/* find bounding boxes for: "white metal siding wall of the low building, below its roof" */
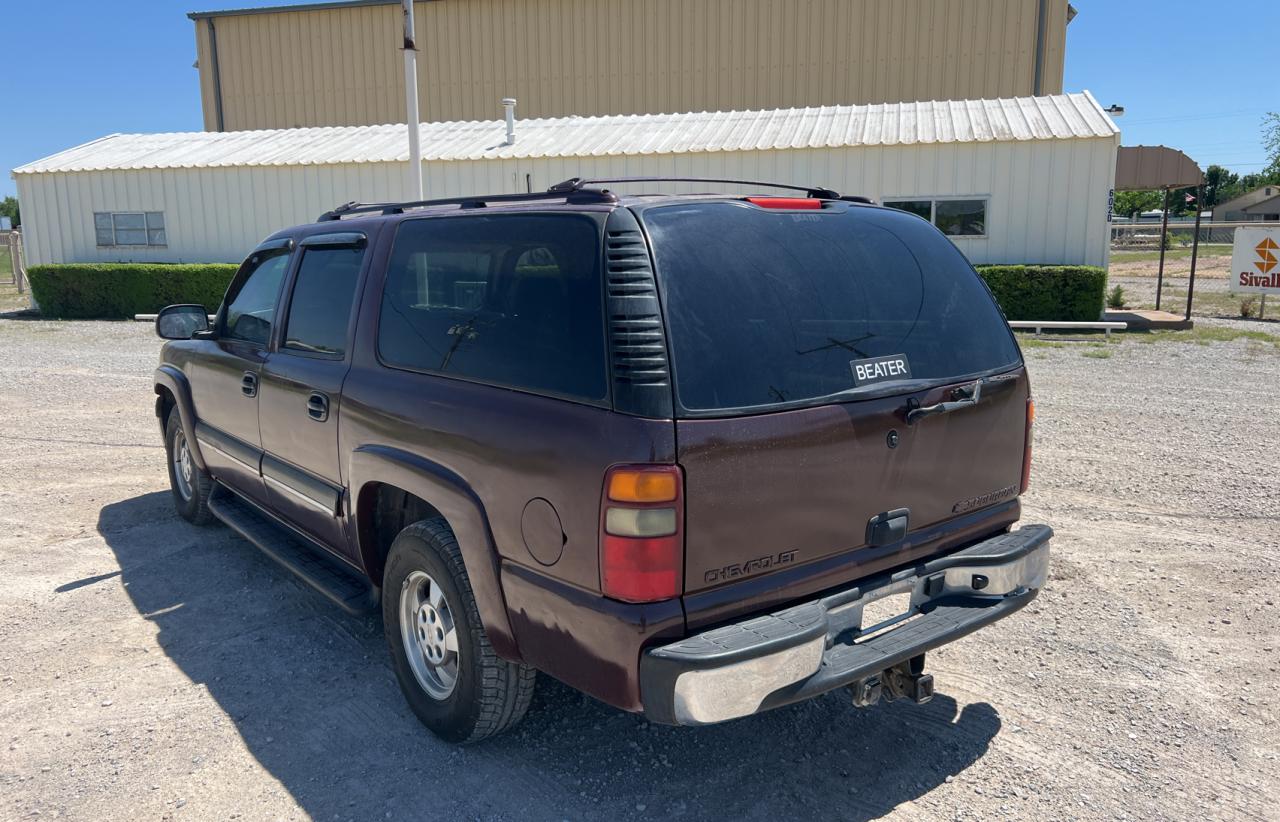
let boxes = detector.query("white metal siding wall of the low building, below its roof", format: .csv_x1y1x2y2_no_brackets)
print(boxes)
15,134,1119,265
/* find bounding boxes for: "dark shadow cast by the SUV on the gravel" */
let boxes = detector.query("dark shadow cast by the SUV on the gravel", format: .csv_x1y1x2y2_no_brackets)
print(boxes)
97,493,1001,819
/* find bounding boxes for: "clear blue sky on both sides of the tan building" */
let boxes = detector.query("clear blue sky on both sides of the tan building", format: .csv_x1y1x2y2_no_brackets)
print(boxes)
0,0,1280,197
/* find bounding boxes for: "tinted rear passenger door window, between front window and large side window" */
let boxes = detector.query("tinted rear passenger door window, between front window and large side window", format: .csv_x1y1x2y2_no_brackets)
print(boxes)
284,248,365,356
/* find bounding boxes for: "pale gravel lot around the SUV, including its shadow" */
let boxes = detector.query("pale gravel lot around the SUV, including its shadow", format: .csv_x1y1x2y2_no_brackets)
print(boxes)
0,320,1280,819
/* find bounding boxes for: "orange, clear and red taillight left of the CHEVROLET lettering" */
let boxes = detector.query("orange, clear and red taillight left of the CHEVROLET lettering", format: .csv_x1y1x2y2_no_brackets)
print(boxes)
600,465,685,602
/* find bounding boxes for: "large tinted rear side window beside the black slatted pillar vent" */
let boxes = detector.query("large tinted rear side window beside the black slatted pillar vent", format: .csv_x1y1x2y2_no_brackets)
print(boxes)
378,214,607,399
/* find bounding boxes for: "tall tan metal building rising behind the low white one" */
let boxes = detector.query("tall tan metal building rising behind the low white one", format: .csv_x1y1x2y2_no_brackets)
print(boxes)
191,0,1075,131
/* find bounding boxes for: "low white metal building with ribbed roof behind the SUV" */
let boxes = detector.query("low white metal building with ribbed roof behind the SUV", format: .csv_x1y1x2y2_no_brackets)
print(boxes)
14,92,1120,265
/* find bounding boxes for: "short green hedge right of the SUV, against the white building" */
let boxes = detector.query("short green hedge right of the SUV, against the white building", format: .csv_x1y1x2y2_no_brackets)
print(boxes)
978,265,1107,323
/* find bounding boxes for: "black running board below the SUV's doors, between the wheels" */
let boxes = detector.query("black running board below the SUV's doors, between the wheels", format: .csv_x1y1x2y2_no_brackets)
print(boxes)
209,487,378,616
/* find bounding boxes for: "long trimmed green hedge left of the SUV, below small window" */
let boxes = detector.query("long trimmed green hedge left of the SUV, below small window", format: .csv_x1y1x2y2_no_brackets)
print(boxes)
28,262,237,320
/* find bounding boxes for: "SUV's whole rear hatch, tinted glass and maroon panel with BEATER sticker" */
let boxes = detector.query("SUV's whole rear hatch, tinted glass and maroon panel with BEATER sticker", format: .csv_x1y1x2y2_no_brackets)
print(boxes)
639,200,1028,594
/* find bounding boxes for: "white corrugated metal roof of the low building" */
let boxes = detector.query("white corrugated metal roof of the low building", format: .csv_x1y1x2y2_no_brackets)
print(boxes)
14,92,1119,174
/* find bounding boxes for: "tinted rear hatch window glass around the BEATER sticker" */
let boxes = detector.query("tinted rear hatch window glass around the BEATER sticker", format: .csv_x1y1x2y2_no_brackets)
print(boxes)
644,202,1020,411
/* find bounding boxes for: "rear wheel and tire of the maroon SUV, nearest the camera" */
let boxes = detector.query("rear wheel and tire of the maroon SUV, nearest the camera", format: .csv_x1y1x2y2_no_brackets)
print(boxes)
383,519,536,745
